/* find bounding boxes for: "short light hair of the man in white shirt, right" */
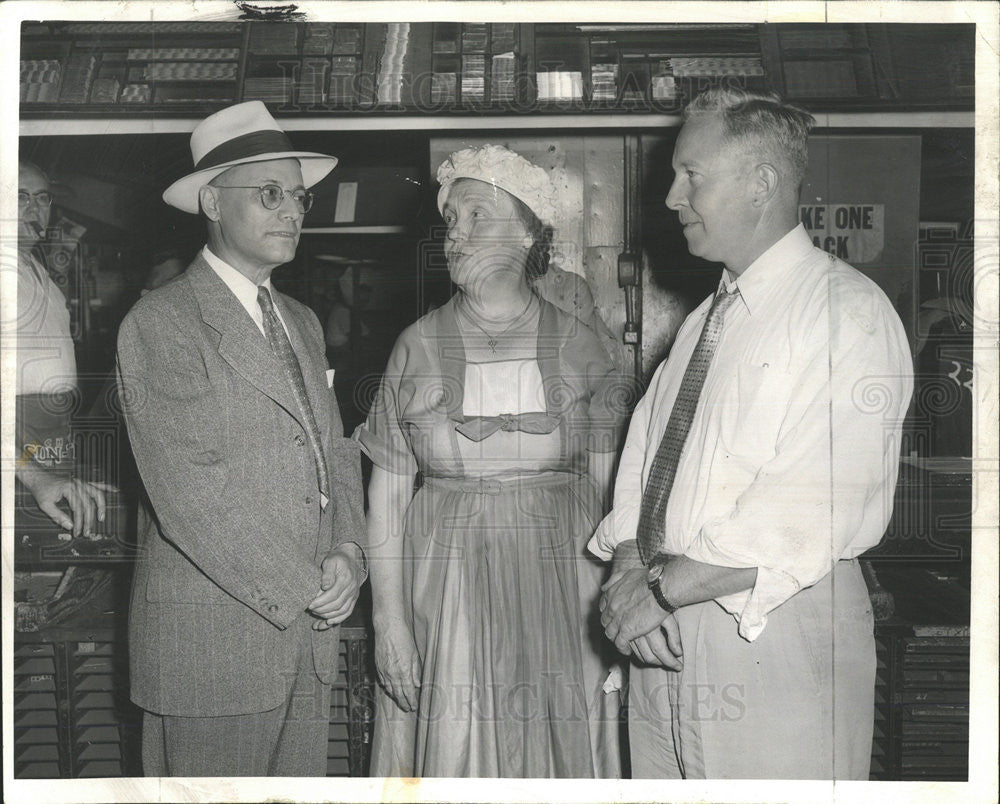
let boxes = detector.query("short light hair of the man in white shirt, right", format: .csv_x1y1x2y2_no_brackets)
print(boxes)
684,87,816,188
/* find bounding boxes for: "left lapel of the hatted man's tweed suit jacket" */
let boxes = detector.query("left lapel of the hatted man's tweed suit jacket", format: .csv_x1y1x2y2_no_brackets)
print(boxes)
188,255,304,426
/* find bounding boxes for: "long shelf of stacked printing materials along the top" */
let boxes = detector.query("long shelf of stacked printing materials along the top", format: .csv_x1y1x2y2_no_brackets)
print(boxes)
21,22,975,115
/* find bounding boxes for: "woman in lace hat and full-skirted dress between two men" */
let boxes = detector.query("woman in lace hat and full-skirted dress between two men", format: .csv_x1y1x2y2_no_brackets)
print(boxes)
355,145,625,777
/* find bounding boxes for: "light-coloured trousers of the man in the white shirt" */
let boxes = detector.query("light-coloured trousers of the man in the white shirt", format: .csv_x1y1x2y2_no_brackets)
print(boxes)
628,560,875,780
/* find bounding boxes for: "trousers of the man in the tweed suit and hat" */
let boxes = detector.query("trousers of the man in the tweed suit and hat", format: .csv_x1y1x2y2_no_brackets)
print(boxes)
142,617,330,777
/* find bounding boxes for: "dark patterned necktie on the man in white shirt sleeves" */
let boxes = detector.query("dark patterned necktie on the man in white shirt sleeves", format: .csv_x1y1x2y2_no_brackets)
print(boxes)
636,288,740,564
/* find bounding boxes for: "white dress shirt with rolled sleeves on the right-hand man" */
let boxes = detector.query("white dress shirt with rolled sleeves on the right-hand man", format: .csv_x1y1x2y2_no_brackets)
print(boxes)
589,225,913,641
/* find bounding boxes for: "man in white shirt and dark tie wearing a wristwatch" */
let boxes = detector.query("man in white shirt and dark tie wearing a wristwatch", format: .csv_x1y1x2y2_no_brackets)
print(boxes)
590,89,913,779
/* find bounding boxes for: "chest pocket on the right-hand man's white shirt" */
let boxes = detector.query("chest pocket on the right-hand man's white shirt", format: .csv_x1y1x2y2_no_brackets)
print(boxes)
722,362,792,464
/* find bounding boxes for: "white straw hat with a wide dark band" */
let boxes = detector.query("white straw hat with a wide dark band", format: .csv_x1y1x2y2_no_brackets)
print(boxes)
163,101,337,214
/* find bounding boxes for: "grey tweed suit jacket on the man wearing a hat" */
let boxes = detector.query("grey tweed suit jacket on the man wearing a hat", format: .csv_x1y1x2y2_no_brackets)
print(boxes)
118,255,365,717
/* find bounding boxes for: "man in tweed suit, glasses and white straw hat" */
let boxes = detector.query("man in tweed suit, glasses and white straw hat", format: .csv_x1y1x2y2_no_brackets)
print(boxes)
118,101,367,776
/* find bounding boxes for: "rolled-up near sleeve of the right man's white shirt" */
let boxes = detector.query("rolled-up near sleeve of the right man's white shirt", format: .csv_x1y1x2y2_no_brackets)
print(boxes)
688,297,913,640
